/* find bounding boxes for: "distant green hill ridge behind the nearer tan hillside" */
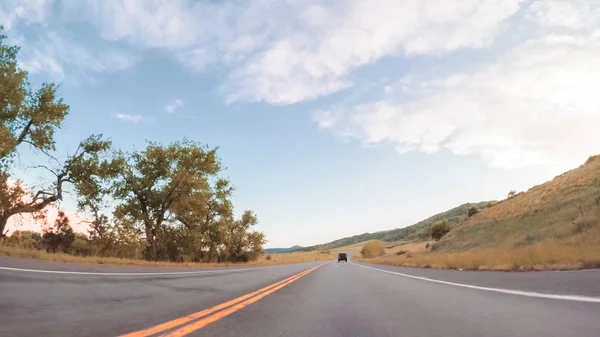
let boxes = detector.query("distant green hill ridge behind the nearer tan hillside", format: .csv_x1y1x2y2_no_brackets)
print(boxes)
304,201,494,251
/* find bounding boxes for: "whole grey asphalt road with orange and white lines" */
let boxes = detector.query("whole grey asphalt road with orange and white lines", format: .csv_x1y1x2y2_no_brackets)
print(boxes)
0,258,600,337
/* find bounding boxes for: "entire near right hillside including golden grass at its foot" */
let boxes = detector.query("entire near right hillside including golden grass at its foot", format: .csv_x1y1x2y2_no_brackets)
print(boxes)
358,156,600,270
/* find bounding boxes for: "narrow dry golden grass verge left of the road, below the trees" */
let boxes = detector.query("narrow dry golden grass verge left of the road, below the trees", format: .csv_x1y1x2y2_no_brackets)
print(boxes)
0,245,335,268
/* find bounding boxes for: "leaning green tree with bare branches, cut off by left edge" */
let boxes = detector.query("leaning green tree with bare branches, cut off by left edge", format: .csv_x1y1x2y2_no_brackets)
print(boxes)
0,26,116,237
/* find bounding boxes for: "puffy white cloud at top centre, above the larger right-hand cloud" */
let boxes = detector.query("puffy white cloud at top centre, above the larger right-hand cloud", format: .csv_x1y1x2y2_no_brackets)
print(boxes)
231,0,521,104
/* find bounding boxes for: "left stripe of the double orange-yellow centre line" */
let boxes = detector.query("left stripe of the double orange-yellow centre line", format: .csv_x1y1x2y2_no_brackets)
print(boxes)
120,265,322,337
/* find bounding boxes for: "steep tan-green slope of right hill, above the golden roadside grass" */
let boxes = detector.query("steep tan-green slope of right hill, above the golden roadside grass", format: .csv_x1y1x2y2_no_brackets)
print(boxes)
438,156,600,251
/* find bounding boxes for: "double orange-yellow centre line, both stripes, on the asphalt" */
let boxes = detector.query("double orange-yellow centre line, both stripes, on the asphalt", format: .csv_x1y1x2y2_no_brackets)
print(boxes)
120,265,322,337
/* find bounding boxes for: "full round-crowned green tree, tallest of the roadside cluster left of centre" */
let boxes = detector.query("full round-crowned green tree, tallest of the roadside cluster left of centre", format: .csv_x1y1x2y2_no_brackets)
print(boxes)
113,140,221,260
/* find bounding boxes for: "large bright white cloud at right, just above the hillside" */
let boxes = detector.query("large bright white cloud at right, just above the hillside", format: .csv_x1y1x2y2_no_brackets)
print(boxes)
314,12,600,168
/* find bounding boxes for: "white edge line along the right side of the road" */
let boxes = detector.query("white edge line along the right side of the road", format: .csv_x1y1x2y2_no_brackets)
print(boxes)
352,263,600,303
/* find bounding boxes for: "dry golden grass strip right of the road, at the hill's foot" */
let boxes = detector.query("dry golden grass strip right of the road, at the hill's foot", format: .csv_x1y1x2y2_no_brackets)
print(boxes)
357,227,600,271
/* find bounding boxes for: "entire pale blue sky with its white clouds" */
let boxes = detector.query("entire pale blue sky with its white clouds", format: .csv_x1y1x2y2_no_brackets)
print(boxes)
0,0,600,247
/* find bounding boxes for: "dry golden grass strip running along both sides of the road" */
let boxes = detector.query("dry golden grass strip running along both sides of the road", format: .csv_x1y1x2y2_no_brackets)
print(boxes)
0,231,600,271
